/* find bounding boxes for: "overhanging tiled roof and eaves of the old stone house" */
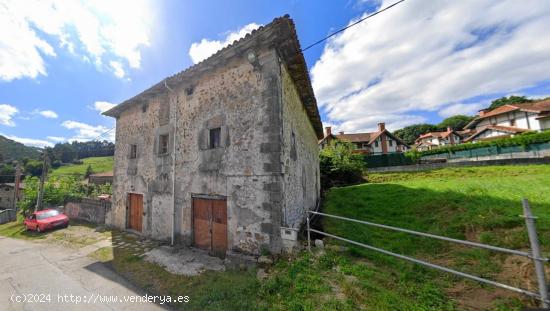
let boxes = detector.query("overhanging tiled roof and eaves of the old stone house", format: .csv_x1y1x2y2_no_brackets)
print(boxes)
103,15,323,139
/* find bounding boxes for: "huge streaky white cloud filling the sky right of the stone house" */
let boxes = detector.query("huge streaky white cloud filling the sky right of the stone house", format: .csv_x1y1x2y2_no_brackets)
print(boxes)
312,0,550,129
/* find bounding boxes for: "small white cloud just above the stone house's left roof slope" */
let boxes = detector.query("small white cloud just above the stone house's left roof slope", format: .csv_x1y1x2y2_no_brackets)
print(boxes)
189,23,261,64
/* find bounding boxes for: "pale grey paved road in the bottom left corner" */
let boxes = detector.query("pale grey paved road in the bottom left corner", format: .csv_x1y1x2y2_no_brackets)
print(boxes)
0,237,166,311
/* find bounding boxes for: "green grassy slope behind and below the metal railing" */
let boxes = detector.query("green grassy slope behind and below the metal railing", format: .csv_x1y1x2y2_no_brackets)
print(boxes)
323,165,550,310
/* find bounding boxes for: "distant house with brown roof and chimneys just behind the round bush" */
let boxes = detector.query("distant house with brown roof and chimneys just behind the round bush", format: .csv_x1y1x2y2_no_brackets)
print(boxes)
319,122,410,155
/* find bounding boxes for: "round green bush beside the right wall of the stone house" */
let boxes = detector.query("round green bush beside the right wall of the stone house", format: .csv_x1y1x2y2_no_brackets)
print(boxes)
319,140,366,189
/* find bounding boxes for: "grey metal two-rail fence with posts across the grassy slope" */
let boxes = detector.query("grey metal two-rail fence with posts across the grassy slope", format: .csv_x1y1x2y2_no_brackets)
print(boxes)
306,199,550,308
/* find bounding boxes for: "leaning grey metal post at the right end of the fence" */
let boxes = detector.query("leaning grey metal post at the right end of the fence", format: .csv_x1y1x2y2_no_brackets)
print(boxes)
522,199,549,308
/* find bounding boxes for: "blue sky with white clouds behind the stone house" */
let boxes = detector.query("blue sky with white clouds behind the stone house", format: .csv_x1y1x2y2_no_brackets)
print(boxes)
0,0,550,146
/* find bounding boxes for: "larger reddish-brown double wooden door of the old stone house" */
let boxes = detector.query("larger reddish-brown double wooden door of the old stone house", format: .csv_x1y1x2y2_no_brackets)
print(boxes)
193,198,227,257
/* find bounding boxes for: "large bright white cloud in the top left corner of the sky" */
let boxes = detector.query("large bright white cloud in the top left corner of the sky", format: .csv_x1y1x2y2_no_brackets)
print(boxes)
0,0,154,81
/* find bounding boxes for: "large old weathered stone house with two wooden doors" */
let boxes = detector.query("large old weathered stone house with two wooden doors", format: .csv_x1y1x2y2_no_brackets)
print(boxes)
104,16,323,257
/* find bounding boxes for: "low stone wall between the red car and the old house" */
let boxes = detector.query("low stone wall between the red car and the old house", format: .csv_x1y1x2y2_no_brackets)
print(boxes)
63,198,111,224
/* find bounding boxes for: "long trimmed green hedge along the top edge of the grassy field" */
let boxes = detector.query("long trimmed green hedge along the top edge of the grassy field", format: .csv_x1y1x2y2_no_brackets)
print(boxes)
405,131,550,160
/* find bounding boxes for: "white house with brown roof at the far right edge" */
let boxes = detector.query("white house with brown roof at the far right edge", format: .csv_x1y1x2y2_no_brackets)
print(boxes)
465,99,550,142
